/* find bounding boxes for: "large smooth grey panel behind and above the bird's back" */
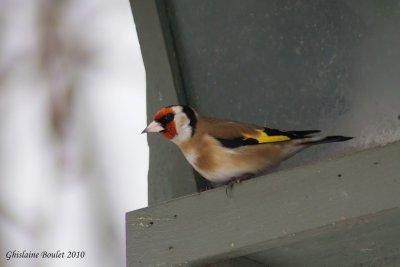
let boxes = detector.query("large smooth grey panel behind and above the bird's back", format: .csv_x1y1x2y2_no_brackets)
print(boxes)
166,0,400,169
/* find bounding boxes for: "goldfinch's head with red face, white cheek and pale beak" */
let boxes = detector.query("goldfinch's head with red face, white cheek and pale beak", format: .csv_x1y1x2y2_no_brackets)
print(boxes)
142,105,198,143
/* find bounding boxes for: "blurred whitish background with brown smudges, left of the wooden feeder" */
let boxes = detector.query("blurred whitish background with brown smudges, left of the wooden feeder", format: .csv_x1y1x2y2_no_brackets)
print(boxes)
0,0,148,267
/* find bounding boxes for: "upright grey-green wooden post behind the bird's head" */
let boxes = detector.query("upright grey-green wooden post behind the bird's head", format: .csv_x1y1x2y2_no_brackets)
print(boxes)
130,0,196,203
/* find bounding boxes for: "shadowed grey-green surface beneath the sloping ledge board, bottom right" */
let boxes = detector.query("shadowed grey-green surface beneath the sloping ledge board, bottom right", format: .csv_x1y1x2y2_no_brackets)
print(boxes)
248,208,400,267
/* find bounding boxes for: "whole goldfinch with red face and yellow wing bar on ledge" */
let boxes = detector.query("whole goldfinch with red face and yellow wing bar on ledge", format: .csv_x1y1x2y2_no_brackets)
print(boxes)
142,105,352,185
